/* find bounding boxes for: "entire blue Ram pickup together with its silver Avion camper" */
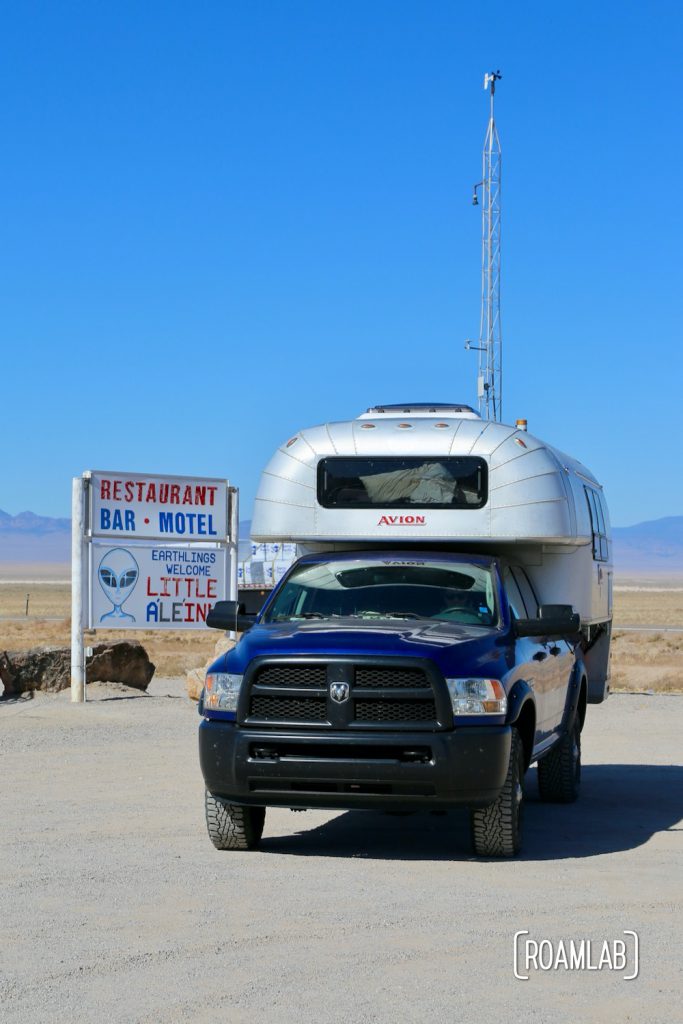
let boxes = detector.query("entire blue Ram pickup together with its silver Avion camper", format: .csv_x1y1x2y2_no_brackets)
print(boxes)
200,403,612,856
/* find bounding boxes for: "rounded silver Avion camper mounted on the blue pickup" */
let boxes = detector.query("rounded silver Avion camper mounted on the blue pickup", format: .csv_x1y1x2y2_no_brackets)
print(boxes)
252,403,612,702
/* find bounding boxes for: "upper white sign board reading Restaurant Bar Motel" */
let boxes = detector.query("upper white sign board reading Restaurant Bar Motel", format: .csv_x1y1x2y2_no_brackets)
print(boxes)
89,470,228,544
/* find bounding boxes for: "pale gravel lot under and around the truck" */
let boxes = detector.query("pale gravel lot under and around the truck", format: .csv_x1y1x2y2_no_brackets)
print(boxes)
0,680,683,1024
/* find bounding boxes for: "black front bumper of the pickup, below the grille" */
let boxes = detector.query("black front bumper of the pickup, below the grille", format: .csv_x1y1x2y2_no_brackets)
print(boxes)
200,719,510,809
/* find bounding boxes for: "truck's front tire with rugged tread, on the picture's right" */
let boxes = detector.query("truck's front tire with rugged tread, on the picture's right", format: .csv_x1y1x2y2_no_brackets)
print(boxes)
470,729,524,857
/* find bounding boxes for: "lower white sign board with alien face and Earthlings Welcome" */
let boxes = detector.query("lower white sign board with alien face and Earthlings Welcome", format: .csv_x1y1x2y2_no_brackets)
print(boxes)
87,541,227,630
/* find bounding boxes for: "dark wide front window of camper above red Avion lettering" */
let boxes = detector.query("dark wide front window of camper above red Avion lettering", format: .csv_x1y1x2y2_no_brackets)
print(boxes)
317,456,487,509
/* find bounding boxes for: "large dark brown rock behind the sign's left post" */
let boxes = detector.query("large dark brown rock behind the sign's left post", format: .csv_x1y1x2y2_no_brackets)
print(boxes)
0,640,155,696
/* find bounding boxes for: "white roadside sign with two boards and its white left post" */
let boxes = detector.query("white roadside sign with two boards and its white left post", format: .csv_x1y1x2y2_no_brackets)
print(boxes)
72,470,233,701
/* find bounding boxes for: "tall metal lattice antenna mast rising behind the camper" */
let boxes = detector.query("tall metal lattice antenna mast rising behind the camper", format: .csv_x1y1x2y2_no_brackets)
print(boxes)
466,71,503,421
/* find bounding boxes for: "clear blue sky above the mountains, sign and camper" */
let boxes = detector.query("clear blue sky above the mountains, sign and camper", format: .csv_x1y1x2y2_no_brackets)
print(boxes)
0,0,683,525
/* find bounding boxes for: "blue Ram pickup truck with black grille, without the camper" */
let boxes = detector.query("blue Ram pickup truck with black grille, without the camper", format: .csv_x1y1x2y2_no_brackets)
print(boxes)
199,549,587,857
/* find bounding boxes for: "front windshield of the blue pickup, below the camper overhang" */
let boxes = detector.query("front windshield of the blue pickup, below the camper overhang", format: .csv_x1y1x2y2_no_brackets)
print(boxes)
263,558,498,627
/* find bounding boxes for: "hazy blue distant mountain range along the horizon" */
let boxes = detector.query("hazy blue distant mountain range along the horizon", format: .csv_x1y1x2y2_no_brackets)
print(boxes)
0,510,683,572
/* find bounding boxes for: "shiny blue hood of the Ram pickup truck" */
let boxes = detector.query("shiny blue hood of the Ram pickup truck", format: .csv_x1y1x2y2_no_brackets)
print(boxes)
219,618,507,678
